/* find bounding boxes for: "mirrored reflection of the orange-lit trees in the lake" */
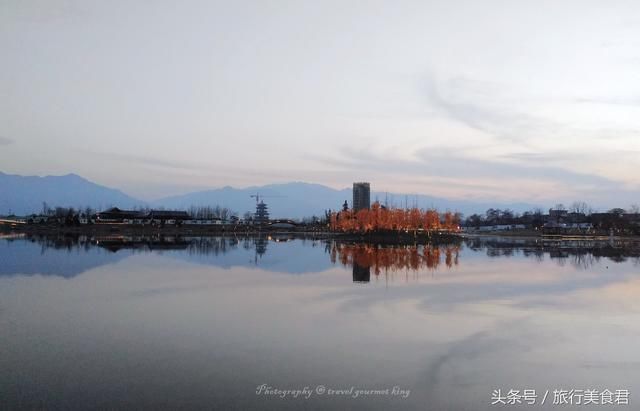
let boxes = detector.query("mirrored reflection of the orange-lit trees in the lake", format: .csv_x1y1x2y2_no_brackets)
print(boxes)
331,243,460,275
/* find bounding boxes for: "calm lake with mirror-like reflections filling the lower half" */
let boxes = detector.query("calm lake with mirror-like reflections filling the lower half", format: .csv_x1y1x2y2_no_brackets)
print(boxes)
0,236,640,411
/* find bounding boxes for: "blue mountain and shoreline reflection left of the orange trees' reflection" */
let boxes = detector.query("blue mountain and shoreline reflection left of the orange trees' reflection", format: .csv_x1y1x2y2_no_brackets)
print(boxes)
0,234,338,277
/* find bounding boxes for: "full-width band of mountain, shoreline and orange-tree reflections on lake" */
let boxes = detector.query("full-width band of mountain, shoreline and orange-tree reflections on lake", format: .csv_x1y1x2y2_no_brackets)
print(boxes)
0,235,640,283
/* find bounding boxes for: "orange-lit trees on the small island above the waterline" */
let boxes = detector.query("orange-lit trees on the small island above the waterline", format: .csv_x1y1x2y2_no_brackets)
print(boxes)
330,202,460,232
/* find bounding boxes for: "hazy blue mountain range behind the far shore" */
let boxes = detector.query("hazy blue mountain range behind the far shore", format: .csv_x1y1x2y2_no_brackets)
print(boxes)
0,172,538,218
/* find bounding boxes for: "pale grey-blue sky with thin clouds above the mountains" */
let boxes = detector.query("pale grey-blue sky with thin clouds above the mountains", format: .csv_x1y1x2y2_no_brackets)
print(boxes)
0,0,640,207
